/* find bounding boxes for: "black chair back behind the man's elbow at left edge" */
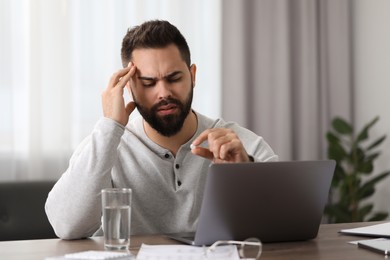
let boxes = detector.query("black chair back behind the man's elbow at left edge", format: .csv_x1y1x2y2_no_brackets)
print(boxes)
0,181,57,241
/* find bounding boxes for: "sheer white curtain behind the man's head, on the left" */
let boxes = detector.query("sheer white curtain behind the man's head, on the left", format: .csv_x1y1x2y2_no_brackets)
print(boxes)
0,0,221,181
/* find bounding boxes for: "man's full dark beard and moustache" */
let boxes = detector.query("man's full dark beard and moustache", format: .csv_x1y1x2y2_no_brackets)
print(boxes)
133,85,193,137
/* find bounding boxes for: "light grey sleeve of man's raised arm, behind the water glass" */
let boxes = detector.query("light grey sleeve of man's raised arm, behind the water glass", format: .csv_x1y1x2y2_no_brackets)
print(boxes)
45,118,125,239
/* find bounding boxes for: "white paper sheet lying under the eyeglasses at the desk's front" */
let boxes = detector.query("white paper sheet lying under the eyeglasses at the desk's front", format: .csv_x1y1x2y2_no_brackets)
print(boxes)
137,244,240,260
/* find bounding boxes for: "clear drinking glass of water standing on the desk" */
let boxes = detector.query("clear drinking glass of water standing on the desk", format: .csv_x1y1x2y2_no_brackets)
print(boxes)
102,188,131,250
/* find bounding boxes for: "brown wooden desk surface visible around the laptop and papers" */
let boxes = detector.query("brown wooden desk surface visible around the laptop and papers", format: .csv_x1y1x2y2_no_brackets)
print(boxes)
0,223,384,260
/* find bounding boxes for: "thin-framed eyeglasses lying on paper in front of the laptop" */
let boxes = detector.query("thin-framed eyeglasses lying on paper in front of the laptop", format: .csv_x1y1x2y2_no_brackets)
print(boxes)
205,238,263,259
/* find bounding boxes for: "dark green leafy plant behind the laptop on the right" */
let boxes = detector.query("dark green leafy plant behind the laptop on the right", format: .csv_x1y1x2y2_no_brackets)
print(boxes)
325,117,390,223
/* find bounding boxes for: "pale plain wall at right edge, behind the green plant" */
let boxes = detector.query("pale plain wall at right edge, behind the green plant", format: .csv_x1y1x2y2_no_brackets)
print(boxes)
353,0,390,219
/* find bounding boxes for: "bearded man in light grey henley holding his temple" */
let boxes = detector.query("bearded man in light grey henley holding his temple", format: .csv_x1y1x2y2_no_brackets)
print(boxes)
45,21,277,239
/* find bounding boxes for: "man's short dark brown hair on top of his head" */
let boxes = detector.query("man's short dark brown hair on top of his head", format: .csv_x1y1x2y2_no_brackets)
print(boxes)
121,20,191,67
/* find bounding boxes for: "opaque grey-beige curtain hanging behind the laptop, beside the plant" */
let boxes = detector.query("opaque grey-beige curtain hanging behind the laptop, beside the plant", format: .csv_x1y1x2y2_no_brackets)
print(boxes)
222,0,353,160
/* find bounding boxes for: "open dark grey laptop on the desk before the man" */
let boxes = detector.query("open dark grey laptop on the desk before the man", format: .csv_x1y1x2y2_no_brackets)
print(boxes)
167,160,336,246
